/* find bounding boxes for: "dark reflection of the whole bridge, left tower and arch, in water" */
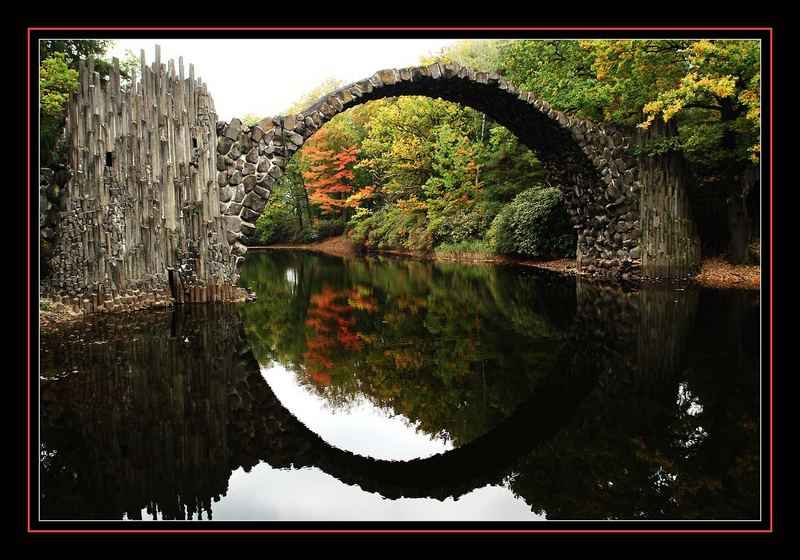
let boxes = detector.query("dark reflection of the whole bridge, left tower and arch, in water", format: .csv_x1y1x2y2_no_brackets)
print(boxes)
42,287,692,519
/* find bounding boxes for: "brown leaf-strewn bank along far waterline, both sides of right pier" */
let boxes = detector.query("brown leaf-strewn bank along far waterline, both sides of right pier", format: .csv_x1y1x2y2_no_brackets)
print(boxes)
250,235,761,290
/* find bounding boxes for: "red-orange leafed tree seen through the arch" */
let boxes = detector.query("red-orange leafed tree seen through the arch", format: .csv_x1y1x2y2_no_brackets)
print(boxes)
303,128,359,214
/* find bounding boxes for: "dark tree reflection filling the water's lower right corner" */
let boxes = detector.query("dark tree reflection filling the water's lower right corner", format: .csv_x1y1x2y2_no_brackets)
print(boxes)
504,289,759,519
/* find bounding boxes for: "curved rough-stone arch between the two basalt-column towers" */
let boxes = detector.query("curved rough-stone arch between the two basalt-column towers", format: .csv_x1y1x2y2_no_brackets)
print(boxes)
217,63,642,279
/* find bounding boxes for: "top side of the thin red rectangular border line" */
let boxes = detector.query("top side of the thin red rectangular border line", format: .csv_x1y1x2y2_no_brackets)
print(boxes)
28,27,772,30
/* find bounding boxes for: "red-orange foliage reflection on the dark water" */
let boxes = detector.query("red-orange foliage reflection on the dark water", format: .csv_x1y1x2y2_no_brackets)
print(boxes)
303,286,374,387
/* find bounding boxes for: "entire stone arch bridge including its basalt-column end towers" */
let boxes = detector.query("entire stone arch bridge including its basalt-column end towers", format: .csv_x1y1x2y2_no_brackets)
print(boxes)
39,52,700,313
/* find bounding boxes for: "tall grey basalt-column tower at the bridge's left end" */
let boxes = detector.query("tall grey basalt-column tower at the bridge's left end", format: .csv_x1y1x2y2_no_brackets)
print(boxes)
42,48,238,312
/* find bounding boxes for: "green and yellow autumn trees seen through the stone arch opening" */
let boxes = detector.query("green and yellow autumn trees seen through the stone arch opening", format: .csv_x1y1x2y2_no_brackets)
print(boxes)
248,95,576,258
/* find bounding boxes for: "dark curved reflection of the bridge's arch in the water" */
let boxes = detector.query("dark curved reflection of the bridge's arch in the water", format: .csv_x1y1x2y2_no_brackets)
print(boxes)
229,344,594,499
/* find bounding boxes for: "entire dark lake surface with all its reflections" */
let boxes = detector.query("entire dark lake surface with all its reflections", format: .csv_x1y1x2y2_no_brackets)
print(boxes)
40,251,760,520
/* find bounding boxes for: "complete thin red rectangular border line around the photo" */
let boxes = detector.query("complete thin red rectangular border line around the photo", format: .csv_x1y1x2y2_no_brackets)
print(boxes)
27,27,774,533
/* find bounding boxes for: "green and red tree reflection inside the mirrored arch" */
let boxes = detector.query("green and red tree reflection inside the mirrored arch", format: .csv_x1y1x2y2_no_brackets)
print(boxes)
243,254,574,443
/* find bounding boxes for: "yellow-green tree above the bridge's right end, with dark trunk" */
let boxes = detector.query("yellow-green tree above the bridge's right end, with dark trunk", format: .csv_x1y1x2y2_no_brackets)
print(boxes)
499,40,761,262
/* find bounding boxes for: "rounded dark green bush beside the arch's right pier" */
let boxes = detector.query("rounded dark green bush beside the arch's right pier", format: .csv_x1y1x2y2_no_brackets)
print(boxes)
488,186,575,258
